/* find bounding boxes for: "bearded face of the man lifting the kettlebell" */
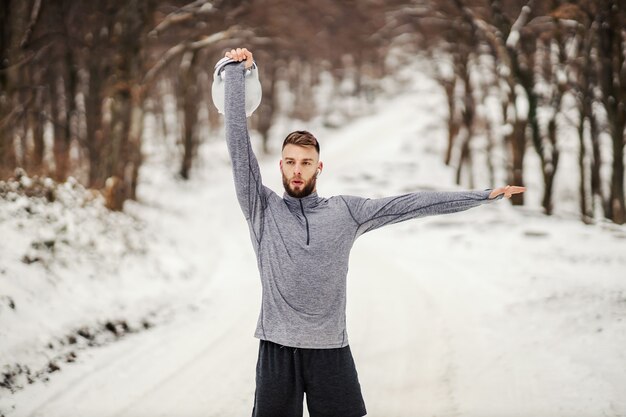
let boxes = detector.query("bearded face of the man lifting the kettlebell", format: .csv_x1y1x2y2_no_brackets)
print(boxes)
280,143,322,198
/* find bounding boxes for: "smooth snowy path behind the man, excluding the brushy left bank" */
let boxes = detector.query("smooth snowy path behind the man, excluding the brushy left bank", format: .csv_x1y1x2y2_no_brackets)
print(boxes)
2,75,626,417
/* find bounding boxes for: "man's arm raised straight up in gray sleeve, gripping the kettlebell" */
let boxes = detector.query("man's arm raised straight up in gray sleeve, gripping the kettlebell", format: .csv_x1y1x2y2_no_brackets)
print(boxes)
219,51,268,242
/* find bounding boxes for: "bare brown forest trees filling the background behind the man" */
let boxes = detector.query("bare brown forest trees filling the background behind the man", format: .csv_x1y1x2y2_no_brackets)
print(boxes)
0,0,626,224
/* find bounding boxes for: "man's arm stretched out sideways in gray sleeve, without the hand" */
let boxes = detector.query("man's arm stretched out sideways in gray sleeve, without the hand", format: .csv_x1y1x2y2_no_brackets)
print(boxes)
341,190,503,235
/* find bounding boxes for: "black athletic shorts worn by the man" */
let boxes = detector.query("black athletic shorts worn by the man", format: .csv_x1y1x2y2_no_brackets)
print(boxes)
252,340,367,417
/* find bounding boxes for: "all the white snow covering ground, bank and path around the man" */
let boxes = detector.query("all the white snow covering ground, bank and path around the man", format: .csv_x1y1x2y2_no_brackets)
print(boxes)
0,65,626,417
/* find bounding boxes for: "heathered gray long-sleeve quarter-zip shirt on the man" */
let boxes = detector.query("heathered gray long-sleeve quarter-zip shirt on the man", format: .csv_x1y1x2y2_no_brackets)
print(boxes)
225,63,501,348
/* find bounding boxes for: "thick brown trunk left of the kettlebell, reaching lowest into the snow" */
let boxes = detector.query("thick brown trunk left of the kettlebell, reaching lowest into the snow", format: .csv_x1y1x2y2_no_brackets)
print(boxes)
87,0,155,210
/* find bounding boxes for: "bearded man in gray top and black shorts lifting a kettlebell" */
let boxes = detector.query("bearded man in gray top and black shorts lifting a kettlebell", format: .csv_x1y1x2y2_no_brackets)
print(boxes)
216,48,525,417
